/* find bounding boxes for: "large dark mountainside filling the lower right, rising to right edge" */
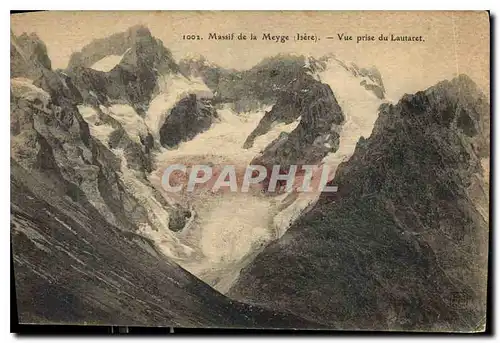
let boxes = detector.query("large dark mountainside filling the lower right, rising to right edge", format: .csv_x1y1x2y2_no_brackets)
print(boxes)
228,75,489,331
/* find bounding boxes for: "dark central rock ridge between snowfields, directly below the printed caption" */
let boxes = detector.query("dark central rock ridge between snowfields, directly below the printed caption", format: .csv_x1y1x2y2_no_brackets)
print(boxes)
180,55,348,168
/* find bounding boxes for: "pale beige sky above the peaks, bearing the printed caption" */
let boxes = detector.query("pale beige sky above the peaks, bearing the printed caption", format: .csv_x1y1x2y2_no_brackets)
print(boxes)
11,11,490,99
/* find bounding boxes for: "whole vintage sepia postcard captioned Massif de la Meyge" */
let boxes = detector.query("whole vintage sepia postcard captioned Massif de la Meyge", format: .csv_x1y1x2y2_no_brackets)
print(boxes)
10,11,490,332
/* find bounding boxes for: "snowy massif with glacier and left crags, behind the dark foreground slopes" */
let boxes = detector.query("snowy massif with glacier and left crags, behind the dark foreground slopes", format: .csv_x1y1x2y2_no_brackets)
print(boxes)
11,26,394,298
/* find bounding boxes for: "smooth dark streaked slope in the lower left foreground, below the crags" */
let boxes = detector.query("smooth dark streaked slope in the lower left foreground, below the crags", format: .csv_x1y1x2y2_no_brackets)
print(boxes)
11,162,320,328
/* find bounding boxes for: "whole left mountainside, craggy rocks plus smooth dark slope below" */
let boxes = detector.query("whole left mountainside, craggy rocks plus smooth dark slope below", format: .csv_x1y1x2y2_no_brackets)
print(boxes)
11,29,319,328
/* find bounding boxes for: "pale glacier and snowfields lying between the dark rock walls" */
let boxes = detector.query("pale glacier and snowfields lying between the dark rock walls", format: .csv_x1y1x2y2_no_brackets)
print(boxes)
79,59,390,292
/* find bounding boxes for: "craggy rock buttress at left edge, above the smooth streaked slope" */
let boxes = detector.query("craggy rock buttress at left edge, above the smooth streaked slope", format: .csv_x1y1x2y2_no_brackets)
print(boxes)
11,66,152,235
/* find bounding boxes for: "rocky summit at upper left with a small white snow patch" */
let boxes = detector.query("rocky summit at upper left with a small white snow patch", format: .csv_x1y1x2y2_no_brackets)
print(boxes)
67,26,178,114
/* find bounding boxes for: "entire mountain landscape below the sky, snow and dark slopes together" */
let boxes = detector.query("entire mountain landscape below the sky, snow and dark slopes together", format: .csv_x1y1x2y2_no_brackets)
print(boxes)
11,26,490,331
